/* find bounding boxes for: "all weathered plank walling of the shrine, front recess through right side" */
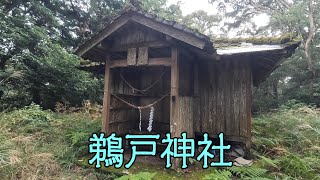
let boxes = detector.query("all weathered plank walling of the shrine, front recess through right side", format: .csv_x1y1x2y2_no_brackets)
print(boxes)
104,23,252,146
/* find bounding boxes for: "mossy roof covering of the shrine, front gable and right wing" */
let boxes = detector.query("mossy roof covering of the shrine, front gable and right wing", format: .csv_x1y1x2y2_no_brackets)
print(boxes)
75,6,300,55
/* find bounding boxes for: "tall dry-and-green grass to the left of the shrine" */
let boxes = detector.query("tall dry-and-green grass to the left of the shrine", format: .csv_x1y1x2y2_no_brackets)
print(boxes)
0,105,100,179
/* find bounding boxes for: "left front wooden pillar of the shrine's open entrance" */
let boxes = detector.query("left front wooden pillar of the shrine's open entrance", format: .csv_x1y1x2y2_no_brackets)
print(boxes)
101,54,111,135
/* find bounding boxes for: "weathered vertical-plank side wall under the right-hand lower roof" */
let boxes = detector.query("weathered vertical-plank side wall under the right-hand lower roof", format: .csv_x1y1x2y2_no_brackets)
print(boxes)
194,59,252,145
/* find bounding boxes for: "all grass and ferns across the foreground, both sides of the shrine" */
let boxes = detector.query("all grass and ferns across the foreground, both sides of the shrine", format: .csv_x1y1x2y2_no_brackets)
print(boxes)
0,103,320,180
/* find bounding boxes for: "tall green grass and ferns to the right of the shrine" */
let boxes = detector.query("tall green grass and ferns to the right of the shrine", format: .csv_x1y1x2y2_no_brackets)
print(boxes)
253,102,320,179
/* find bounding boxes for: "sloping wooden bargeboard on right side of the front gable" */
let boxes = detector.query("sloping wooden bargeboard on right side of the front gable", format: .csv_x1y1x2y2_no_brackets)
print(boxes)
131,15,206,49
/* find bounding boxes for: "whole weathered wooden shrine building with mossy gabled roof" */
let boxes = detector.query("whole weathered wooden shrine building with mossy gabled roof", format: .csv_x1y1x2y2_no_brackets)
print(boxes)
76,9,299,147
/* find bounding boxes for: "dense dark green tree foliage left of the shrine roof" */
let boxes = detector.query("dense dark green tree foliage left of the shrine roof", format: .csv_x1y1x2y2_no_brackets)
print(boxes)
0,0,188,111
